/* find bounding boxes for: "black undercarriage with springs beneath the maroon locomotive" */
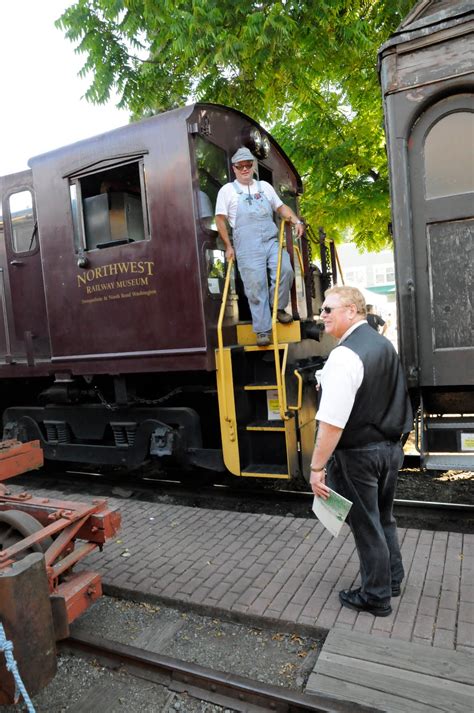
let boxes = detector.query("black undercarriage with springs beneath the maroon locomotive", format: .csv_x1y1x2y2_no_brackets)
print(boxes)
3,377,225,471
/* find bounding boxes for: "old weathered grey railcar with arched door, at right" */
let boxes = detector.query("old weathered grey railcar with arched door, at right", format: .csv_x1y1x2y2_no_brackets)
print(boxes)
379,0,474,470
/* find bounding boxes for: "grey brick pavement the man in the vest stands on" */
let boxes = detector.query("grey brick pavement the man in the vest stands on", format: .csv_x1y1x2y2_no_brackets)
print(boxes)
60,493,474,653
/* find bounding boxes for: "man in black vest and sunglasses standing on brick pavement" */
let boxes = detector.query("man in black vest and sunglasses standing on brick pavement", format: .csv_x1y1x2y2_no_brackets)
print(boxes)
310,287,413,616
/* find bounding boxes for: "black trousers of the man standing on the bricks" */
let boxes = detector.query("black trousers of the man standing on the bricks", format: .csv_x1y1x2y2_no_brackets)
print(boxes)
327,441,404,604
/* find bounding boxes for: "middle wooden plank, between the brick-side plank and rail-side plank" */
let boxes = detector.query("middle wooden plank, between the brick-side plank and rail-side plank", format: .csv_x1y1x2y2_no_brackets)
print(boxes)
316,648,474,713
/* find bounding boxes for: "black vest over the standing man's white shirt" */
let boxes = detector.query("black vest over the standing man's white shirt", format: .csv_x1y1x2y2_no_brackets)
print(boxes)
336,324,413,448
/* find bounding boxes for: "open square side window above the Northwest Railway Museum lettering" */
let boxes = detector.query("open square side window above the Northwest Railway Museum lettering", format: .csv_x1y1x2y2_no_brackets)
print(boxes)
70,160,150,252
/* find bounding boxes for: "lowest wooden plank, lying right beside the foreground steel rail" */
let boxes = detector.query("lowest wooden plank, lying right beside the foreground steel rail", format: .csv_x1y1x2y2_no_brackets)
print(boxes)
305,673,435,713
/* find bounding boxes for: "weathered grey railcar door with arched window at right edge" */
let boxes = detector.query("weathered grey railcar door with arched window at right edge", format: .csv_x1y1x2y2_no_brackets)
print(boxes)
409,94,474,386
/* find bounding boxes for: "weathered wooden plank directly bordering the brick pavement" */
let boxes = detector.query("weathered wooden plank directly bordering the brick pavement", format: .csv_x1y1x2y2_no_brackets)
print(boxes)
323,629,474,684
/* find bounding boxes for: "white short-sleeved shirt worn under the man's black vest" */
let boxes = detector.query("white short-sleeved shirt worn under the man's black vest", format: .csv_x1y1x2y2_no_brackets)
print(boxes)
316,319,367,428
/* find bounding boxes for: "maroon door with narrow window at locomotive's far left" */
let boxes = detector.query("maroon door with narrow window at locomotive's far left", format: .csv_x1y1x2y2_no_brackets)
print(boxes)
0,171,50,365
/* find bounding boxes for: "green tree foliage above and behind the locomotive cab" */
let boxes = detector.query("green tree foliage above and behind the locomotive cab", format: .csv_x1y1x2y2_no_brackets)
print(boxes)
57,0,415,249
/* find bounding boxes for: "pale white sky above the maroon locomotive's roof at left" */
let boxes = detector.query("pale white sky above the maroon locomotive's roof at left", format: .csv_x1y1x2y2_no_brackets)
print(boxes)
0,0,128,176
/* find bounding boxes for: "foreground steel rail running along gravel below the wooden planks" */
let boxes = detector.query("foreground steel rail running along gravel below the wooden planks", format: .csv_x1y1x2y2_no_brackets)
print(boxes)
58,633,380,713
